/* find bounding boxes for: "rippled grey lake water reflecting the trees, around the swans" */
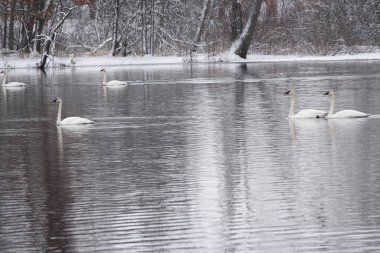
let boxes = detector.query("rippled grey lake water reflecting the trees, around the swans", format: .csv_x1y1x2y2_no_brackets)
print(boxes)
0,61,380,253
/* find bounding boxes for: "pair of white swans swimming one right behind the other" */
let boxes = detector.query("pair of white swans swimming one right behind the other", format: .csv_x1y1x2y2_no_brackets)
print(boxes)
284,89,370,119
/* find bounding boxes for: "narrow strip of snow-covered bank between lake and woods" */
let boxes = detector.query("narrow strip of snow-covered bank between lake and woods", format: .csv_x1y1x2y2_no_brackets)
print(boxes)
0,53,380,69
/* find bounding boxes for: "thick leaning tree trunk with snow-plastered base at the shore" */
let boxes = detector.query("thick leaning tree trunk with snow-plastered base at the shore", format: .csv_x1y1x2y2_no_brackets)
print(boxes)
230,0,263,59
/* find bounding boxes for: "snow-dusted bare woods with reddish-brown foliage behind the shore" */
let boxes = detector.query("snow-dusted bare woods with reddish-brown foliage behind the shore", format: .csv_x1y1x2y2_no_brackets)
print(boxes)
0,0,380,57
